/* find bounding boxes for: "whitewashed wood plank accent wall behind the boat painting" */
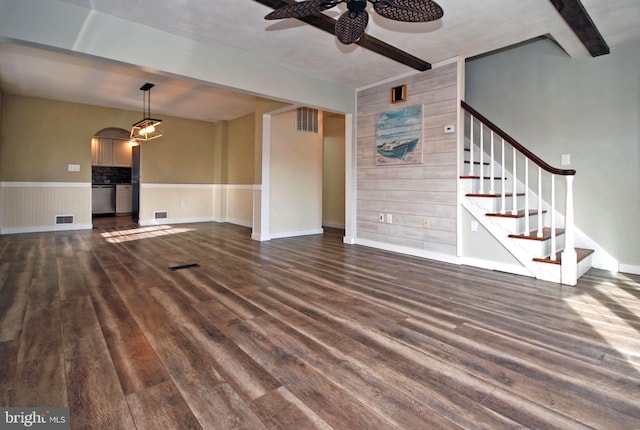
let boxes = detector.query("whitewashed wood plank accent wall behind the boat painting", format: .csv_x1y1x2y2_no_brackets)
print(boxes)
356,63,459,256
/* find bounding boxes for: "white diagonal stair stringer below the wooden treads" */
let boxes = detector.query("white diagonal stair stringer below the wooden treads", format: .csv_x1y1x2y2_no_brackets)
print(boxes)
461,196,561,282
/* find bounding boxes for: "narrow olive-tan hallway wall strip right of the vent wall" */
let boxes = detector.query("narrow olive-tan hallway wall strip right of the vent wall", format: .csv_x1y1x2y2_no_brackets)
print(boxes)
322,112,345,228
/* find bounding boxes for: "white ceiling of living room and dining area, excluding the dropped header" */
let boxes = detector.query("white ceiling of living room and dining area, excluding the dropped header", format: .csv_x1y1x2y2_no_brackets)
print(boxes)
0,0,640,121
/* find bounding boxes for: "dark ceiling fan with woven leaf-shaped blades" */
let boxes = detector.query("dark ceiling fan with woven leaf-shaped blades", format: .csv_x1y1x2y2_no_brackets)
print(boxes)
264,0,444,45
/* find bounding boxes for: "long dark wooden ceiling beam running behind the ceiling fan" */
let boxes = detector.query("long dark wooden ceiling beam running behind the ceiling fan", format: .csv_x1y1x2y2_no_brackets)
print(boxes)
250,0,431,72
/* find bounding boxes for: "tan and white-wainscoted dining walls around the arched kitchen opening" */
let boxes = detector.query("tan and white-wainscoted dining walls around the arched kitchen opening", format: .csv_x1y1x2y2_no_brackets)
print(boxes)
0,95,254,233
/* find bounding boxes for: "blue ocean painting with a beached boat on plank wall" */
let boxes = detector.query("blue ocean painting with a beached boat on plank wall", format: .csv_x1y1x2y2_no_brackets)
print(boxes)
376,105,422,166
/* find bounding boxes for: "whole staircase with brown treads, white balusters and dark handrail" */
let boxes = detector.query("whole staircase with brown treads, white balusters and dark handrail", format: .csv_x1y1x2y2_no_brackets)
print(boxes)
460,101,593,285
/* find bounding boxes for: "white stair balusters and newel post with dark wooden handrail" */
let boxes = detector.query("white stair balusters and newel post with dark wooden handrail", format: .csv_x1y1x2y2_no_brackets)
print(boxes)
461,101,577,285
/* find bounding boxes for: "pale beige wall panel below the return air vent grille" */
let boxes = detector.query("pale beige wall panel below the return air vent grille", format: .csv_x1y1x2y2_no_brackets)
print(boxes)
270,107,322,237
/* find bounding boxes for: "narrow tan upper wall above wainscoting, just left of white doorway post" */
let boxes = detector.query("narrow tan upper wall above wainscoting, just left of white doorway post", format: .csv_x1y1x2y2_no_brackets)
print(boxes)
226,113,256,184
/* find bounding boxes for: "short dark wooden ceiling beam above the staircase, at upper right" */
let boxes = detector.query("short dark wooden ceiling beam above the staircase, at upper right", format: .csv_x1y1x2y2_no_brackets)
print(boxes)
549,0,609,57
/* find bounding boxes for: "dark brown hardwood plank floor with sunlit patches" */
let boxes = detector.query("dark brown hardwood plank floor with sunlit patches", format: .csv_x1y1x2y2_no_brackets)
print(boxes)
0,223,640,430
